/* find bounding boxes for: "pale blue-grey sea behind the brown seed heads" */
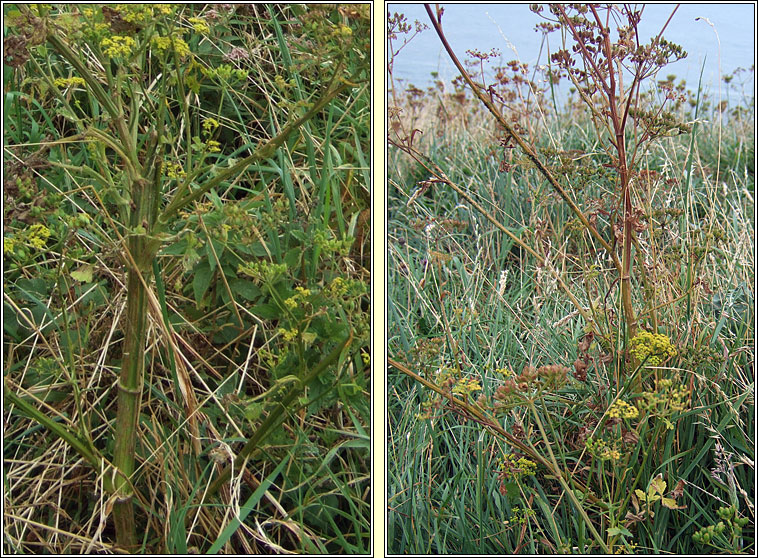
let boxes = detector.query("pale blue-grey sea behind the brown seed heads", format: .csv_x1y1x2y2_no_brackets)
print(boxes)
387,2,756,98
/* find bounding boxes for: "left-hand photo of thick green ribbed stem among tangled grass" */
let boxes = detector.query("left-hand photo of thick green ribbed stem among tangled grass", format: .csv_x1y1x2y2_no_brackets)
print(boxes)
3,4,370,554
